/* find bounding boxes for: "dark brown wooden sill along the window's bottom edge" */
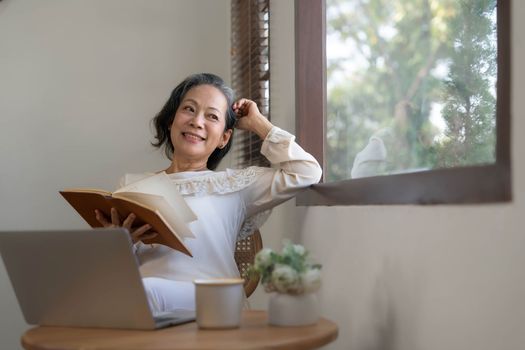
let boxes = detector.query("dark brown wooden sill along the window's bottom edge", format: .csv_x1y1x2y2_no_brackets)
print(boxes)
296,164,512,206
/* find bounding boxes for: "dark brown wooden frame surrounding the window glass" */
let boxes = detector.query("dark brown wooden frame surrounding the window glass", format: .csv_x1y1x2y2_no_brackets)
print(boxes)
295,0,512,205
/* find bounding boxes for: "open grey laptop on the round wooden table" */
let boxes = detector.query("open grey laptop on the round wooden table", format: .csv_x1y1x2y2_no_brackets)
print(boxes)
0,228,195,329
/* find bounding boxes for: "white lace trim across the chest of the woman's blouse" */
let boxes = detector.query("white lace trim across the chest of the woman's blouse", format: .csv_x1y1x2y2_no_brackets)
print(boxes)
169,166,264,197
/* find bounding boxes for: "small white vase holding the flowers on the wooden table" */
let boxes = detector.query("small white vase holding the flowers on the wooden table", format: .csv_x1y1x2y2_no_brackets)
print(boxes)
268,293,319,326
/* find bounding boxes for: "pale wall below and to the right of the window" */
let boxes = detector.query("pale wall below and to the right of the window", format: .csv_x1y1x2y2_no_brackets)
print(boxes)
264,0,525,350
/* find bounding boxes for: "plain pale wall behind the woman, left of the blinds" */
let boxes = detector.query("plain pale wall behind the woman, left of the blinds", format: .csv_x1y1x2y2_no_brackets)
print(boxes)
0,0,230,349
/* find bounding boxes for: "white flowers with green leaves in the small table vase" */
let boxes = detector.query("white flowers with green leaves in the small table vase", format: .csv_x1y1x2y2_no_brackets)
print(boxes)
247,241,321,295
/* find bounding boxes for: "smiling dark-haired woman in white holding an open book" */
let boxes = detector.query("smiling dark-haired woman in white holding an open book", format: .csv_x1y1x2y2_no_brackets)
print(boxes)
97,74,321,311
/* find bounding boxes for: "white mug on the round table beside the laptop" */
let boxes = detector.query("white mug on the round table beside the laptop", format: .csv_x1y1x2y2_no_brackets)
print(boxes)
193,278,244,328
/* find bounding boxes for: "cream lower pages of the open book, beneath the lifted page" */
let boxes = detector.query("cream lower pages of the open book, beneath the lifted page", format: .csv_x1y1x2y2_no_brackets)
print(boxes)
113,192,195,238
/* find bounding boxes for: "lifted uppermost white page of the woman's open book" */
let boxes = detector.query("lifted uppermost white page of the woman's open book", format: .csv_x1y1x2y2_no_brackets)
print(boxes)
113,172,197,222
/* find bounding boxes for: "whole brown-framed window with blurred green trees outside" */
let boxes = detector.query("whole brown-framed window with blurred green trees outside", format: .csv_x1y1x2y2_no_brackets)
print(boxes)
296,0,511,205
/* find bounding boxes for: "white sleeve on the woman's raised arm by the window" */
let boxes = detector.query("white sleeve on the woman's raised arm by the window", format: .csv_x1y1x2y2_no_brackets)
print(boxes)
241,126,322,217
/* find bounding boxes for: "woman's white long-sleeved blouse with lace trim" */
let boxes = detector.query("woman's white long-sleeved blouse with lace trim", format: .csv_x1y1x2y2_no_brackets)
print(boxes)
121,126,321,281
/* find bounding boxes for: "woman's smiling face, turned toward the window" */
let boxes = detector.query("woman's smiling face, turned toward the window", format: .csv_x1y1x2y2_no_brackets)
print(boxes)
170,85,232,165
